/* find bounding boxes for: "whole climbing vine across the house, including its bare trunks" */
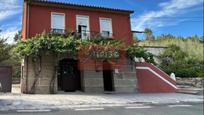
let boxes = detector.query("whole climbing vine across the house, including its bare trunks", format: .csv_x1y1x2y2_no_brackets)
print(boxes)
15,33,153,93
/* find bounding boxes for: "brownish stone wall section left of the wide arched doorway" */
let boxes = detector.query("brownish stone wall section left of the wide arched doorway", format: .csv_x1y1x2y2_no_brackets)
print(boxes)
21,55,57,94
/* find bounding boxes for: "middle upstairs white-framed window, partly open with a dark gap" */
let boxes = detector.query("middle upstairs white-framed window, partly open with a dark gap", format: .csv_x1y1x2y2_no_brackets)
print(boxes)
76,15,90,40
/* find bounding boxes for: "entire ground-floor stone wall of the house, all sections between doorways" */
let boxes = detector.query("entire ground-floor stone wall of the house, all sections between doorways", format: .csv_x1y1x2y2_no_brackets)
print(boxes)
21,55,137,94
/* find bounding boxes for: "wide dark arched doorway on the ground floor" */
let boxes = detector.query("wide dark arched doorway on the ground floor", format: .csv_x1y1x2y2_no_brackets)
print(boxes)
58,59,81,91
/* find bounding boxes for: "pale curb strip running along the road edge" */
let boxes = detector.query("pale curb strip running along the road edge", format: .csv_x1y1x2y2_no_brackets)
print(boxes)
0,101,203,113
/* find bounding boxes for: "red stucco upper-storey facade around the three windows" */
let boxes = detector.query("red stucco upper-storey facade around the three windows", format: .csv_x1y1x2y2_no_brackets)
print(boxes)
22,2,133,44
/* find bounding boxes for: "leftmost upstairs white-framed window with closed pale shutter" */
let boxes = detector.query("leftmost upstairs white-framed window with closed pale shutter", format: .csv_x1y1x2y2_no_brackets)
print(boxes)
51,12,65,33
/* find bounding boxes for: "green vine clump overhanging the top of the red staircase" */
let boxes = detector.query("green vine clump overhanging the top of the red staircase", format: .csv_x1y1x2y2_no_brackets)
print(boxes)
126,45,155,64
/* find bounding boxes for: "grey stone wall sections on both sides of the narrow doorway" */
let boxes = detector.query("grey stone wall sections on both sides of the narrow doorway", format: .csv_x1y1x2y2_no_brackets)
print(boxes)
81,61,137,93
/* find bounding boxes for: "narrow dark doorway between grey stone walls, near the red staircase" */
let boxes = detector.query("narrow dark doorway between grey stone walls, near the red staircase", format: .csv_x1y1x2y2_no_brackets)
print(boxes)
103,61,114,91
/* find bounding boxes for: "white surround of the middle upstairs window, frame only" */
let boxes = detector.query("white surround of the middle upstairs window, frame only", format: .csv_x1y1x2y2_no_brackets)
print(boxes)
76,15,90,39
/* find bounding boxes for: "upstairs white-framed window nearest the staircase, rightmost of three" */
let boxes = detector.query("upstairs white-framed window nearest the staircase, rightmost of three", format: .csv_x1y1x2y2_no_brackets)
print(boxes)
99,18,113,38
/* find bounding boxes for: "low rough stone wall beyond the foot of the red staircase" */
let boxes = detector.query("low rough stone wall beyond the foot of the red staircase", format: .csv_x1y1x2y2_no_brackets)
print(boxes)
176,77,204,88
